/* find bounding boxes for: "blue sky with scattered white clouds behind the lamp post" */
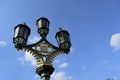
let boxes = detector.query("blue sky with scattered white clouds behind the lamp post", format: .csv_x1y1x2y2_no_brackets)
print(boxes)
0,0,120,80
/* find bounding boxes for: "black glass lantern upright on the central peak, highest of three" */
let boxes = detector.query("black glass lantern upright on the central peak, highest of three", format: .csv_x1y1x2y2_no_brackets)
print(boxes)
36,17,50,37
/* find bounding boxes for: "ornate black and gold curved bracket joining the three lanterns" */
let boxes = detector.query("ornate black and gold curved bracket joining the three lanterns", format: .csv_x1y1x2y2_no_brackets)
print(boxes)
16,38,64,67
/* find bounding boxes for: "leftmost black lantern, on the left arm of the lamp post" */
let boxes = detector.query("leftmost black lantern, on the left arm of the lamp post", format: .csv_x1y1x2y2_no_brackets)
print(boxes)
13,24,31,45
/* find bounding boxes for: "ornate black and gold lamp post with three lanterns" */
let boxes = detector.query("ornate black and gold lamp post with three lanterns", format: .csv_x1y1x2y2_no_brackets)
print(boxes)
13,17,71,80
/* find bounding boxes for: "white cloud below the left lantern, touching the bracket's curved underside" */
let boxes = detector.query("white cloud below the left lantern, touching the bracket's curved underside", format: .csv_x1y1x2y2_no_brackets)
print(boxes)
19,52,37,66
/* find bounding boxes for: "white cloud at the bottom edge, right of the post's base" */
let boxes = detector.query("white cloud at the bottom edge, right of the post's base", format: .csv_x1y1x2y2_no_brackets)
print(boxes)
51,71,72,80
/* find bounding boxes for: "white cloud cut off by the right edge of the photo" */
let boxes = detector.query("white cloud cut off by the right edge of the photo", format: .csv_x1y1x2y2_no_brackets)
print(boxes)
110,33,120,50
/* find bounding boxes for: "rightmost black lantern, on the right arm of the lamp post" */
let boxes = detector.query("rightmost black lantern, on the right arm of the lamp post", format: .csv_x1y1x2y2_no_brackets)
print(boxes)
55,28,71,53
